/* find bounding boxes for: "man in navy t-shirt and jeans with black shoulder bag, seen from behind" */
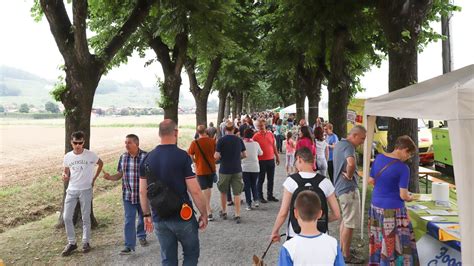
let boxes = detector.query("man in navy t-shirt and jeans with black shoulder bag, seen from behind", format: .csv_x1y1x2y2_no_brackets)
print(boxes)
140,119,208,265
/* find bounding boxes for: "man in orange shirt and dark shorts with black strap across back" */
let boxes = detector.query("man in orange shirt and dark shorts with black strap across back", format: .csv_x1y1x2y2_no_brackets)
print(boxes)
188,125,217,221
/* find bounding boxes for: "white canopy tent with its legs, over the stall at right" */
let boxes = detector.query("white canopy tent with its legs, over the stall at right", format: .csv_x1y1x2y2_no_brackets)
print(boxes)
361,65,474,265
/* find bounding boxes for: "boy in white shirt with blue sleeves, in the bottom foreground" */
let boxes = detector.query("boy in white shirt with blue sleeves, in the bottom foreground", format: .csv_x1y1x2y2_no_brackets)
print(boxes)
278,190,345,266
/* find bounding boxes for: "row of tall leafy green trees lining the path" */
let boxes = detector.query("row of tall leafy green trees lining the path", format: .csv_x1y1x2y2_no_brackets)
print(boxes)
32,0,456,227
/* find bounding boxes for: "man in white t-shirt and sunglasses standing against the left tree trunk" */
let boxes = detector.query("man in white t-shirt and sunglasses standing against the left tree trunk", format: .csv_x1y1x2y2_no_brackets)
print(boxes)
61,131,104,256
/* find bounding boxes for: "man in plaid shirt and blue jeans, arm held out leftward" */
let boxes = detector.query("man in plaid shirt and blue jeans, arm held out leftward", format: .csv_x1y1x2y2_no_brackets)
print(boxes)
104,134,148,255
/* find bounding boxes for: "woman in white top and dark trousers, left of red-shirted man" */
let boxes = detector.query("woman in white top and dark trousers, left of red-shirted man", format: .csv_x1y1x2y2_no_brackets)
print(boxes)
242,128,263,211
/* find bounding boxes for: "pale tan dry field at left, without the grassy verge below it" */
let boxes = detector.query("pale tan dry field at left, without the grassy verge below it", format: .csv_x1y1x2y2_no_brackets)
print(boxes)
0,115,216,187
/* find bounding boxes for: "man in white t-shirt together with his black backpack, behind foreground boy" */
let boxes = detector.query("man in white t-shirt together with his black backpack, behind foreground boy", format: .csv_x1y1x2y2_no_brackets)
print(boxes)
271,147,341,242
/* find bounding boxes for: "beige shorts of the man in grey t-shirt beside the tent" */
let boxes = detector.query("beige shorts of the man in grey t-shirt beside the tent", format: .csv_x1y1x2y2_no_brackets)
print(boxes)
338,189,360,229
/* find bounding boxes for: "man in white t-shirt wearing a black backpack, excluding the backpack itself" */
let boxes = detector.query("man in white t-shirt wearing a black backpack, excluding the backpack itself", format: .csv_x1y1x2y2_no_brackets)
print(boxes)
271,147,341,242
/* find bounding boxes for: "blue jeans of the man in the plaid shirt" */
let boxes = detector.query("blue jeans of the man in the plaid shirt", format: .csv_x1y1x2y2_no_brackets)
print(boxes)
123,200,146,250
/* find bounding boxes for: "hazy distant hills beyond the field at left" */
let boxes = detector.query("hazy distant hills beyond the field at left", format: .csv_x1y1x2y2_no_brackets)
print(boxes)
0,66,159,108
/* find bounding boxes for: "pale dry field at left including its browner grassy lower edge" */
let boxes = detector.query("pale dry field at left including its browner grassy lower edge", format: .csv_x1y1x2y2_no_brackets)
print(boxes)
0,115,215,233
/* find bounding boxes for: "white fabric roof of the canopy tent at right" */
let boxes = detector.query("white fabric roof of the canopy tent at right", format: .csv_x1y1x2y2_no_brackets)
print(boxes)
365,65,474,120
